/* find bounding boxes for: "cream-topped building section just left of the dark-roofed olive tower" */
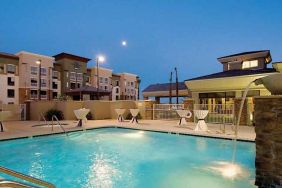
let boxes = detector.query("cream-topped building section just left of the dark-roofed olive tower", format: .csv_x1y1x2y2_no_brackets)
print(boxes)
16,51,55,103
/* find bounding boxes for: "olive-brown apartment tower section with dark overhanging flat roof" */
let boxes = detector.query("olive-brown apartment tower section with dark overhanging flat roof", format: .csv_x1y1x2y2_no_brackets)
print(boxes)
53,52,90,99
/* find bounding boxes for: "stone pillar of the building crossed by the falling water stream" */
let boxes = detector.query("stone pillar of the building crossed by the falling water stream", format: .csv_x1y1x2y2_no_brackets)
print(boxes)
234,98,248,125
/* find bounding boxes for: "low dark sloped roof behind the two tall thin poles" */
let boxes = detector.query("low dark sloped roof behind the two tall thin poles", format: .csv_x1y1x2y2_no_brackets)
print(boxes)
142,82,187,92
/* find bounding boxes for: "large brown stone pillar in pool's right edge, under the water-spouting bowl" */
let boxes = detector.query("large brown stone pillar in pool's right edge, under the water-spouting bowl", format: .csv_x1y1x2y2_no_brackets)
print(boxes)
254,96,282,188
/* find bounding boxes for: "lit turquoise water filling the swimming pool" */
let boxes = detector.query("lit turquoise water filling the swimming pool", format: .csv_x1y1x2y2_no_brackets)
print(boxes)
0,128,255,188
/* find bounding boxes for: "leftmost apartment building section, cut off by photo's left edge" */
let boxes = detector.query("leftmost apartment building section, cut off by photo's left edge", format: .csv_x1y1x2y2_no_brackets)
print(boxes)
0,53,19,104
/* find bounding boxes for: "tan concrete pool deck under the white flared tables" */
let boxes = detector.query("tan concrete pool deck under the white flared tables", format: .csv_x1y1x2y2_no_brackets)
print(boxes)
0,119,256,141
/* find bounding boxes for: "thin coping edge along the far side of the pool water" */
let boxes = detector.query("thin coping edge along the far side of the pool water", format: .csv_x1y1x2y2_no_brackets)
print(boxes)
0,125,255,143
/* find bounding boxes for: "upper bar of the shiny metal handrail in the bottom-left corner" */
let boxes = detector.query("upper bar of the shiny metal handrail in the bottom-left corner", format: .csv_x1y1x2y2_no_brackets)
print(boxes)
0,166,55,188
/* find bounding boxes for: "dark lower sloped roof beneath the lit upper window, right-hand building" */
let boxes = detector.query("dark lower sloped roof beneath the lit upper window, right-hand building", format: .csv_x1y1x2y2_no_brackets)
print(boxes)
185,68,276,81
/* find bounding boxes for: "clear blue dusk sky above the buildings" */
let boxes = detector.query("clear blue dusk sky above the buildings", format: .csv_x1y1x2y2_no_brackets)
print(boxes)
0,0,282,89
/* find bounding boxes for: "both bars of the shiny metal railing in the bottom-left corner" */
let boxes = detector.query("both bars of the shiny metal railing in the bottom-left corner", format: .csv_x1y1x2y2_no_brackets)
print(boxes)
0,166,55,188
